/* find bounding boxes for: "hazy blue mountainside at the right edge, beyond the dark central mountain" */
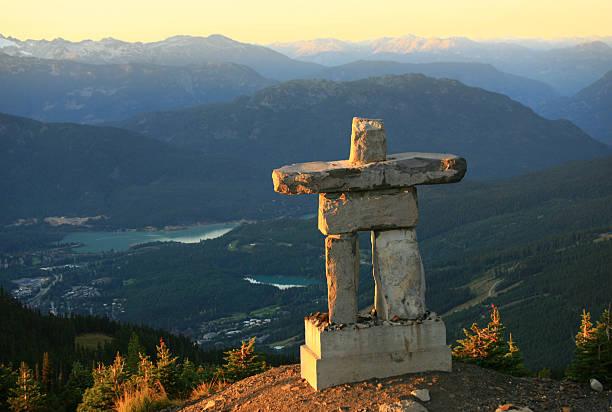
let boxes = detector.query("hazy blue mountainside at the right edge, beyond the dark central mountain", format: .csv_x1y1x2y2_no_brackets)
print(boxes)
540,70,612,146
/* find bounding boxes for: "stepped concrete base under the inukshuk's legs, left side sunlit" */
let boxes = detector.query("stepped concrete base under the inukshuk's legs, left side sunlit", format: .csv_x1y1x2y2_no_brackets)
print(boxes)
300,318,451,390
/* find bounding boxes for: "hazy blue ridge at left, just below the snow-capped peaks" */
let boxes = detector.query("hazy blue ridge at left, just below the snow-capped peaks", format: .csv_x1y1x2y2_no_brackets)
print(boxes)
0,49,275,123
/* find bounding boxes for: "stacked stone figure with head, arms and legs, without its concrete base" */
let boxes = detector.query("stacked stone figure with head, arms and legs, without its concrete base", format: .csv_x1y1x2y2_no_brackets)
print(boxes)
272,117,467,323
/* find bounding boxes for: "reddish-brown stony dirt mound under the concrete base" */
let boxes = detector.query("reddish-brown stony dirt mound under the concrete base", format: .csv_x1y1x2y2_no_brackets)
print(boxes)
173,362,612,412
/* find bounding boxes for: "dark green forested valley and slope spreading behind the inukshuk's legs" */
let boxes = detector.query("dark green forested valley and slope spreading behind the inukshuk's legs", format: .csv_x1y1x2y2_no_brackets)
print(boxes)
0,157,612,368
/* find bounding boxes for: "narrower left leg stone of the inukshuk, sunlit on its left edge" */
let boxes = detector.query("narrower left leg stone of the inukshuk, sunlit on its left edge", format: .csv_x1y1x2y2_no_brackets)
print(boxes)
325,233,359,323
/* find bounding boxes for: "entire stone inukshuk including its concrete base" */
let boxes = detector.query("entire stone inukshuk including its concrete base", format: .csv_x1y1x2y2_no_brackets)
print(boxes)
272,117,467,390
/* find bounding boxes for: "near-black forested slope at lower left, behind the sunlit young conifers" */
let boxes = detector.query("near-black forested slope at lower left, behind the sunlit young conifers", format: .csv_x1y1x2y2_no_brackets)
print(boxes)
0,289,220,378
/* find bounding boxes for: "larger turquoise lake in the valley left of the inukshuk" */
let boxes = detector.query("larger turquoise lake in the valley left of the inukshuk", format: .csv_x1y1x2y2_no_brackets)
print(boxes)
62,224,238,253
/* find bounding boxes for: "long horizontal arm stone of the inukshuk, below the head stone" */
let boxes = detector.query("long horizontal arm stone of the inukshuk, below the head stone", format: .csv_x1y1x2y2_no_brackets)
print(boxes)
272,152,467,195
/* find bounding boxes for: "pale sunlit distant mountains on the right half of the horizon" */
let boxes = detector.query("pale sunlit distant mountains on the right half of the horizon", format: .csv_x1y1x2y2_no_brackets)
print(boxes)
269,35,612,95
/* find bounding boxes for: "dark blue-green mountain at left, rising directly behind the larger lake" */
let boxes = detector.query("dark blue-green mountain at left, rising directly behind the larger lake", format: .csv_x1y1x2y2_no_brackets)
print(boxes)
0,113,284,228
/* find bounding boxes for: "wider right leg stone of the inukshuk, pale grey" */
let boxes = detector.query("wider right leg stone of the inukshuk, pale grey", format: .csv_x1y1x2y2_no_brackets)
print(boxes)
372,228,426,320
